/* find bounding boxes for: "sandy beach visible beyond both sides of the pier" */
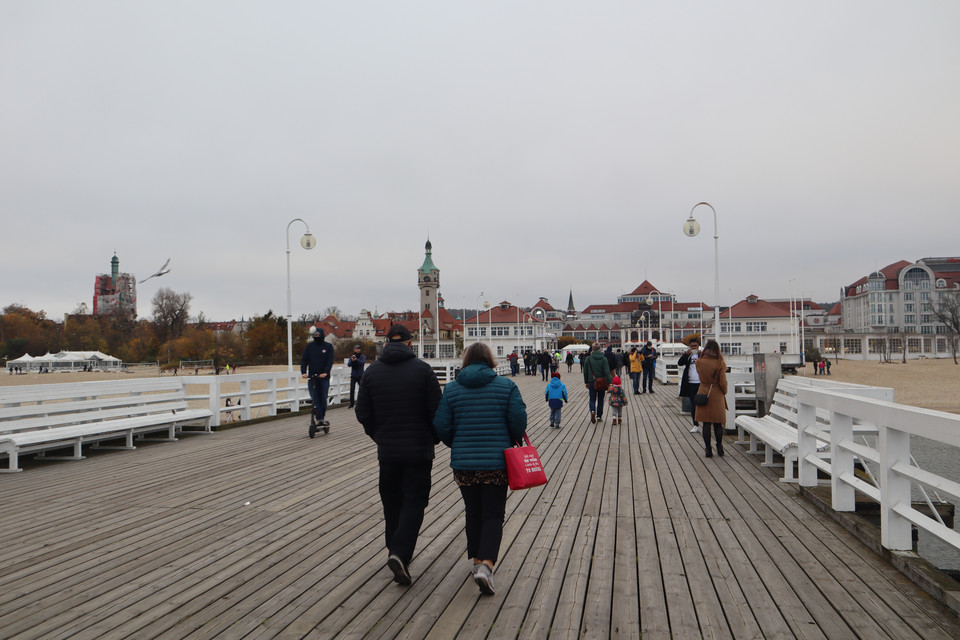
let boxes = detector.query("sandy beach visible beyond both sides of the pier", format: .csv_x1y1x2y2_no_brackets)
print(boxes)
0,358,960,414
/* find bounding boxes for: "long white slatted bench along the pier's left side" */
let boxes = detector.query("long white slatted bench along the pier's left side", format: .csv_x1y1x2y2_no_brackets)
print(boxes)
0,378,213,473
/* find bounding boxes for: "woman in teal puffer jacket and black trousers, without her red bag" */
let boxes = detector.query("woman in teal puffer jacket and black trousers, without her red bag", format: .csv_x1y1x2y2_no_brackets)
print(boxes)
433,342,527,595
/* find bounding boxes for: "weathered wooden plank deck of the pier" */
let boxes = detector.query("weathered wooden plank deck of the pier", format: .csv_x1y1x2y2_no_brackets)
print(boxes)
0,367,960,640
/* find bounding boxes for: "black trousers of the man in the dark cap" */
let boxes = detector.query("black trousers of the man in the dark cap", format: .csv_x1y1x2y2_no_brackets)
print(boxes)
380,460,433,564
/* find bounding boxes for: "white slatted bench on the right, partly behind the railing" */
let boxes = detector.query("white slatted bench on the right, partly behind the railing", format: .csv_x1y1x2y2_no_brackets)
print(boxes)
736,376,893,482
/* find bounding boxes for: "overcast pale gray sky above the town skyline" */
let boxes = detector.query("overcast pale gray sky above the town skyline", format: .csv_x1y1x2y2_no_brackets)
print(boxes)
0,0,960,320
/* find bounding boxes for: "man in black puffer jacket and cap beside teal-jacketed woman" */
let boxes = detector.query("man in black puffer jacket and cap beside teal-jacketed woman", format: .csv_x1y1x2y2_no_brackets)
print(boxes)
356,324,442,585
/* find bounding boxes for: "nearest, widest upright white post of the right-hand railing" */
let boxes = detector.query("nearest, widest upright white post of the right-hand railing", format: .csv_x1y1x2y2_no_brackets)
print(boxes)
878,425,913,551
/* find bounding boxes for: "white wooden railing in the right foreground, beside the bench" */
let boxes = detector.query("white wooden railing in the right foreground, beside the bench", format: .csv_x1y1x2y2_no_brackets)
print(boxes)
797,388,960,550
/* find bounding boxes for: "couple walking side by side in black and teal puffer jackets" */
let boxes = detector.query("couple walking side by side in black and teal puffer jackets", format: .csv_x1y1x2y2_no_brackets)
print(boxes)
355,324,527,595
